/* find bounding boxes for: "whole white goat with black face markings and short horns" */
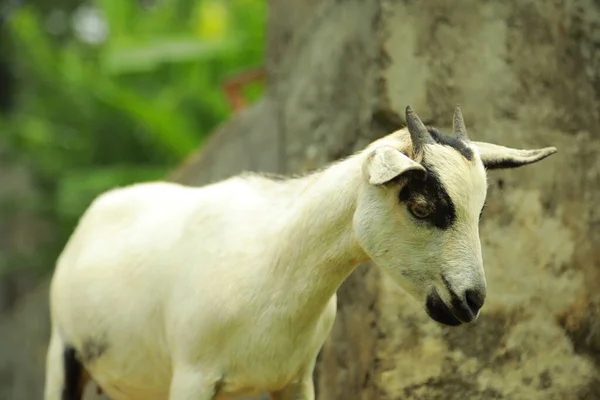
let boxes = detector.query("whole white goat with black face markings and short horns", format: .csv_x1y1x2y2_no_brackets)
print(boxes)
45,107,556,400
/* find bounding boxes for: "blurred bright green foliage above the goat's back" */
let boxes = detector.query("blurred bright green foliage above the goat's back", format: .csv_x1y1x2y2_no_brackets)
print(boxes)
0,0,267,270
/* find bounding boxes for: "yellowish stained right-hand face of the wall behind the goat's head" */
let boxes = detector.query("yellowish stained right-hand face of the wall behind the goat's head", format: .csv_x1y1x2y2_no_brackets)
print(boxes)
364,0,600,399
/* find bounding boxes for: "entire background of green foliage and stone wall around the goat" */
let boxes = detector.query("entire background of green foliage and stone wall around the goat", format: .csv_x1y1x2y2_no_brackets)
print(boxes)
0,0,600,400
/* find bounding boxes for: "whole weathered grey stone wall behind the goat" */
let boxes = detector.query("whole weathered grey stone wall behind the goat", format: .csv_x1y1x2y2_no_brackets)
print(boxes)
0,0,600,400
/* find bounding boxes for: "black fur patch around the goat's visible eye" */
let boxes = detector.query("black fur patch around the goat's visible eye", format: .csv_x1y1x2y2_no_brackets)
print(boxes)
399,161,456,229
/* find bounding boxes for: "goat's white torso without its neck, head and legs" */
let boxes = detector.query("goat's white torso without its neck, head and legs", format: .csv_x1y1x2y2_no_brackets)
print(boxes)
47,177,336,400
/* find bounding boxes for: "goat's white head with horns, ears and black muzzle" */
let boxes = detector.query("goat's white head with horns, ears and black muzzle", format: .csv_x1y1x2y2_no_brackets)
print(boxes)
353,106,556,325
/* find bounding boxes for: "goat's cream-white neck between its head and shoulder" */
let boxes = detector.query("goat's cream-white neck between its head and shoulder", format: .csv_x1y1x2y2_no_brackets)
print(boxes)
277,154,367,318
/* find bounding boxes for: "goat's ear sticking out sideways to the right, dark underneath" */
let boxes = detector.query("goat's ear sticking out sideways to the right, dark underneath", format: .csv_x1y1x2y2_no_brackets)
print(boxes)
471,142,556,169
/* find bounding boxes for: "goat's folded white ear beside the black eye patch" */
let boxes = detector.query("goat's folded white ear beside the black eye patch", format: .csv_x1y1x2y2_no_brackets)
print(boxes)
364,146,427,185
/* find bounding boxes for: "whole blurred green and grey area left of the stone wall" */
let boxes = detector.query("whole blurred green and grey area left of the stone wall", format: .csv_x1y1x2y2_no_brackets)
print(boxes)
0,0,267,400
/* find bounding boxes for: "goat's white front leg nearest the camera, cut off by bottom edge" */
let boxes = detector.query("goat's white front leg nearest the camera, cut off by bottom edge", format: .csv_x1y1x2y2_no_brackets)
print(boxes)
169,368,221,400
